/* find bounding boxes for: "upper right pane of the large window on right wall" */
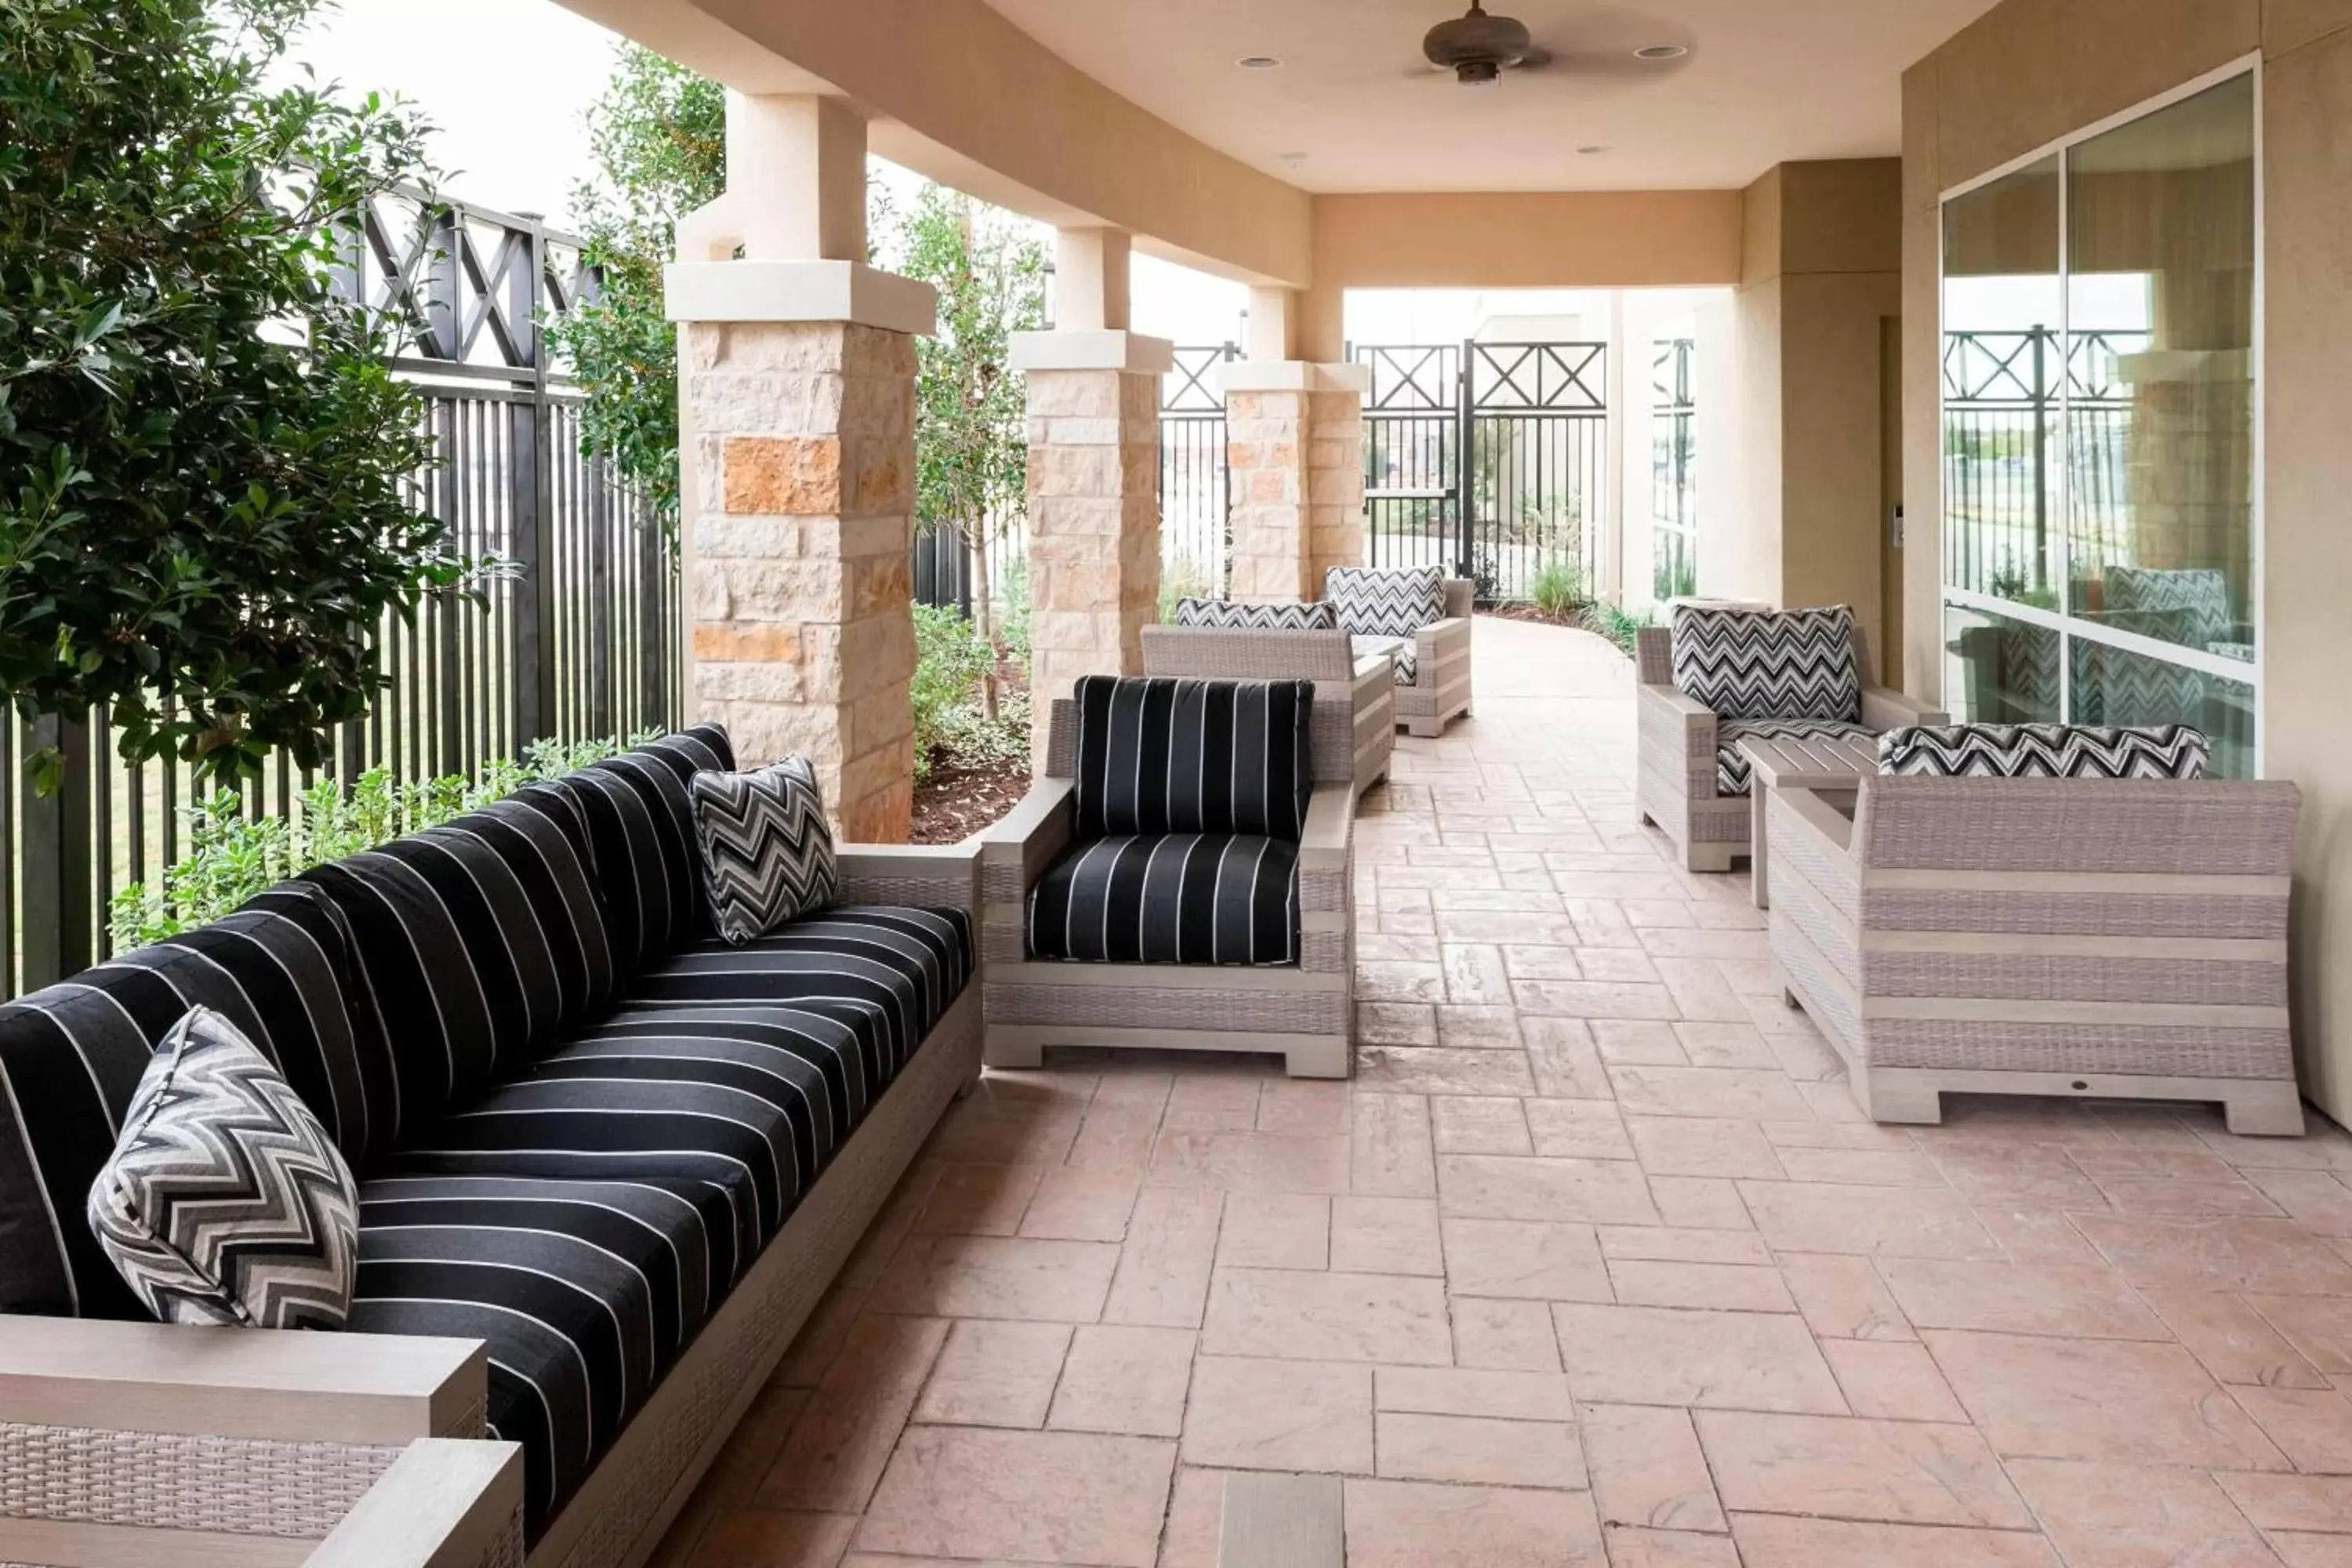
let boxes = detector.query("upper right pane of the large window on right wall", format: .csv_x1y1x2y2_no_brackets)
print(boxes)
2067,78,2256,662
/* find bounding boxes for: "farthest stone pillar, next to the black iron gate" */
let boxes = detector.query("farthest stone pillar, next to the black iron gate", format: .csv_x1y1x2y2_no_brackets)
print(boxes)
1221,360,1369,602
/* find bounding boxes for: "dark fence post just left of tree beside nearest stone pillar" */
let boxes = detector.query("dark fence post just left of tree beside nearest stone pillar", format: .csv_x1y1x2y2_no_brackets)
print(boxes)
506,214,557,753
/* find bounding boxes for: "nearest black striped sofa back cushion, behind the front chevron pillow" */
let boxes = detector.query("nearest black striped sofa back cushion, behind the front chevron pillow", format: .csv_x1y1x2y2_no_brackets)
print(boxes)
0,881,397,1319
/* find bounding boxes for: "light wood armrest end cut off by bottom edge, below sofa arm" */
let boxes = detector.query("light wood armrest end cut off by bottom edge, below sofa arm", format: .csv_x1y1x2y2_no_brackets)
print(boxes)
303,1439,522,1568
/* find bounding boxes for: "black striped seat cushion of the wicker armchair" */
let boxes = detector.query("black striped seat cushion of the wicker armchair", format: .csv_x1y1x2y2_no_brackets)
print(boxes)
1028,832,1298,964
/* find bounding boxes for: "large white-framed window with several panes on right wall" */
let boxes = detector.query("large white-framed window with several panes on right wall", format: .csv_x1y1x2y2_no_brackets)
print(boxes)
1943,71,2260,779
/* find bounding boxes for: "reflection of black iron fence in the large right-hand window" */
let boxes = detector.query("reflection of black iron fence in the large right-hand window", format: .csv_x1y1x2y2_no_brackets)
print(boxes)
1943,327,2150,597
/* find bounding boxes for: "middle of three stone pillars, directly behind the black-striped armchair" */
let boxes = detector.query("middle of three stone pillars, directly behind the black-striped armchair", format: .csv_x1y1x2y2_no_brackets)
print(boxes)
1011,329,1176,767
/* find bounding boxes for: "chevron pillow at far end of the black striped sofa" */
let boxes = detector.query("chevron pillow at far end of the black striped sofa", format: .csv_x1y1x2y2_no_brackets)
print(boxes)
689,757,842,947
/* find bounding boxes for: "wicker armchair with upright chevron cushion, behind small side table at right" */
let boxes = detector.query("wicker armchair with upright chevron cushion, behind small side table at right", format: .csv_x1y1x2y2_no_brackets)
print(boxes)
1635,607,1945,872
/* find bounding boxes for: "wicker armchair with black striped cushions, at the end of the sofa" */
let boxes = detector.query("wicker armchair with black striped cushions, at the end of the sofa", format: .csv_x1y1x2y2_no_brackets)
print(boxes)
981,675,1355,1076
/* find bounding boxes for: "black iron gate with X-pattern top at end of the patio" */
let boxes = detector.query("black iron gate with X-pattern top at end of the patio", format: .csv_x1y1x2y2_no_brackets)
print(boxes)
1350,339,1609,602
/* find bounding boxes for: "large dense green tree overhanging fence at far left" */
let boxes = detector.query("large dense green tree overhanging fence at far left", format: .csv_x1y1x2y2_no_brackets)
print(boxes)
0,0,463,787
